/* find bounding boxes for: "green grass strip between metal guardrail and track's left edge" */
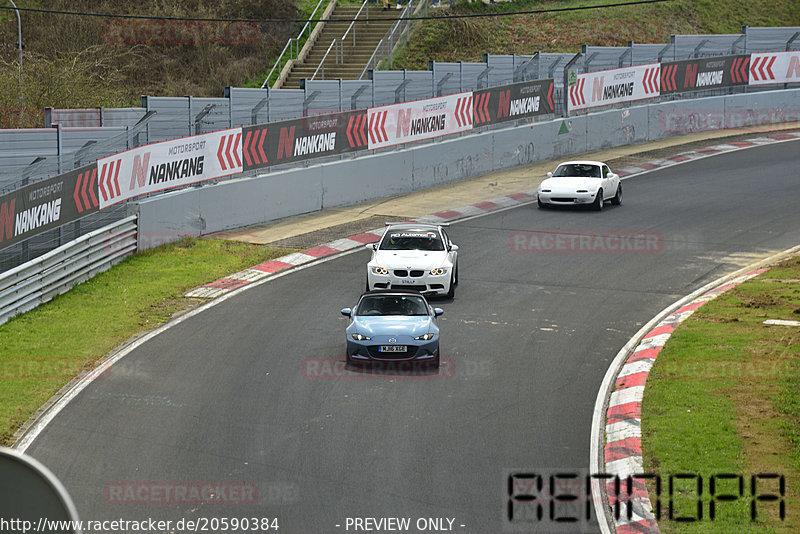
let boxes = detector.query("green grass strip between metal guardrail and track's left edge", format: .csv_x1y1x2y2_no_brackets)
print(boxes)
0,239,294,445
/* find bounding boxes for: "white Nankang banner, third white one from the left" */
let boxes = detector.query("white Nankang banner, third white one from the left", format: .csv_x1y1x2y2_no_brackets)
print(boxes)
567,63,661,111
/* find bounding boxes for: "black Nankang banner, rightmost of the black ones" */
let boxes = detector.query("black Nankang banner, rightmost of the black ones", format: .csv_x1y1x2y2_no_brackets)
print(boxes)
661,55,750,95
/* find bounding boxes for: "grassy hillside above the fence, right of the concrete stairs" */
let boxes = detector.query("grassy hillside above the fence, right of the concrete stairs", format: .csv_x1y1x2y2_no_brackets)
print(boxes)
394,0,800,70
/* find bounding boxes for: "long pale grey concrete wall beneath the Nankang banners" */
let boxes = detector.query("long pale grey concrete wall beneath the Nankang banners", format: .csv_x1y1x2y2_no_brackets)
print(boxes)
136,89,800,248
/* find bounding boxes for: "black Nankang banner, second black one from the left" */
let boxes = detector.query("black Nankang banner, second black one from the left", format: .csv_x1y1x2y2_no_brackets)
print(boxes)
242,110,367,170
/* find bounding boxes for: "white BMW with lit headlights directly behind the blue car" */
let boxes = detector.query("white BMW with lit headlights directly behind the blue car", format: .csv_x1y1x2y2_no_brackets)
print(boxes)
367,223,458,298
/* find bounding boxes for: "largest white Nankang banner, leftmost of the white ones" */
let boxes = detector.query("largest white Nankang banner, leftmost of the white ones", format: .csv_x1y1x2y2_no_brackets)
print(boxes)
97,128,242,209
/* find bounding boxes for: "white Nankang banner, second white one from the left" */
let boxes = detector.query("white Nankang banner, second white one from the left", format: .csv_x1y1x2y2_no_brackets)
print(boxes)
367,92,472,149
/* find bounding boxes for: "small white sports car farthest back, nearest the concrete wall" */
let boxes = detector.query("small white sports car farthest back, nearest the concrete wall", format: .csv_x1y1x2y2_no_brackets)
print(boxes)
538,161,622,210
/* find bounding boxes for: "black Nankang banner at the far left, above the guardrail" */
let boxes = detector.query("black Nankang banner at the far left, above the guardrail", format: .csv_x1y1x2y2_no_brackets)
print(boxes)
0,164,99,249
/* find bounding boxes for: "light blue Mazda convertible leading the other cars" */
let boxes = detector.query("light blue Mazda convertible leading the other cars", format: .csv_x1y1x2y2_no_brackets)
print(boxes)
342,290,444,367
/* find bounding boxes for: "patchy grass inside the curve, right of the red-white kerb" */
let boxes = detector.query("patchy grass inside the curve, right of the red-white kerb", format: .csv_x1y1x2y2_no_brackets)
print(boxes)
642,259,800,533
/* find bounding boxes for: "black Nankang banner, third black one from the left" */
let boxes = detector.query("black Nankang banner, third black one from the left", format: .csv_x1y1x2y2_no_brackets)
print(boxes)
472,79,555,126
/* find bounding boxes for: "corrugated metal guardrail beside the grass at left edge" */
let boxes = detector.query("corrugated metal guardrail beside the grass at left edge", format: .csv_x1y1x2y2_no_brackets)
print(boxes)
0,215,138,324
